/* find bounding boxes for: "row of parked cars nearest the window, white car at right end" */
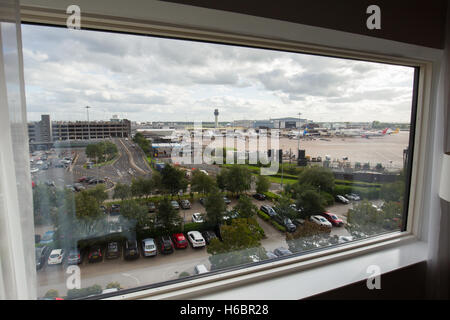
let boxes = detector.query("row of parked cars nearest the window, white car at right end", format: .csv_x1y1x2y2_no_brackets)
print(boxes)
36,231,218,270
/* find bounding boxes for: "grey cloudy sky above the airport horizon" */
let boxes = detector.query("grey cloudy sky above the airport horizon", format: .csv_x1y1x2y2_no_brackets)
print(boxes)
22,25,413,122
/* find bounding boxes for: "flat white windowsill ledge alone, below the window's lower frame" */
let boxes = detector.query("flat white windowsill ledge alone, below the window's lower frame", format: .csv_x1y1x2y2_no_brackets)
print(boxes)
190,241,427,300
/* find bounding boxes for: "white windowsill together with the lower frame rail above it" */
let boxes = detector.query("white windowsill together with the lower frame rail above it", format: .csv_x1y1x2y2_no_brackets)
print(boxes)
103,236,427,300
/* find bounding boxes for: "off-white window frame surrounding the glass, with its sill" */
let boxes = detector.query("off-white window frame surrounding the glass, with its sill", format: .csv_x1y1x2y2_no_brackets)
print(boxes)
21,0,442,299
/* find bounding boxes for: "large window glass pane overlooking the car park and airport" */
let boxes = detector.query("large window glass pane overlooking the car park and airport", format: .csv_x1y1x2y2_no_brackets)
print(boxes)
23,25,415,298
